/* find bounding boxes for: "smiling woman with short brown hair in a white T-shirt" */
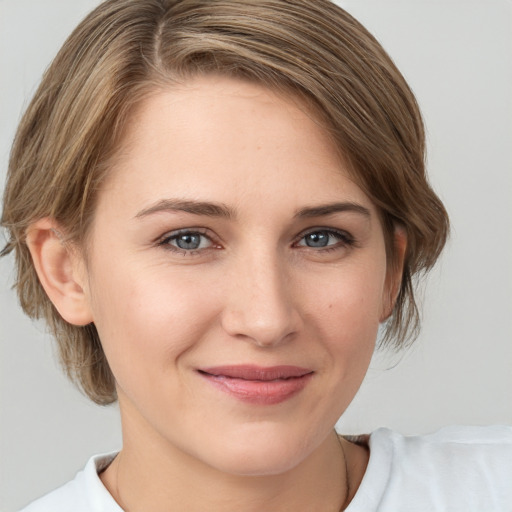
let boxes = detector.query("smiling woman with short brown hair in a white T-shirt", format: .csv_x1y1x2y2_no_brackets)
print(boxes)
3,0,511,511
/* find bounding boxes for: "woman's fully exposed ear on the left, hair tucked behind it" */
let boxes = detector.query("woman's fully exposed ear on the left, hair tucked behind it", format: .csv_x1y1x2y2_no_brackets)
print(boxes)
27,218,93,325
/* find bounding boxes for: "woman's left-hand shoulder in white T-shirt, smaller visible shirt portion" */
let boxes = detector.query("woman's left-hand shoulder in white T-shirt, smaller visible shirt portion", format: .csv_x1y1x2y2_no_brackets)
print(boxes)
20,453,122,512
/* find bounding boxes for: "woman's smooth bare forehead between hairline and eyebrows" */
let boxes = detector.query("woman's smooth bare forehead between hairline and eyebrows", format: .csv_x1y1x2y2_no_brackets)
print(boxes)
98,76,369,214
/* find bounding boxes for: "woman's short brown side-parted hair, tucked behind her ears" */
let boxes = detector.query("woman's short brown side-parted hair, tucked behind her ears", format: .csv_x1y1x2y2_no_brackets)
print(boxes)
2,0,448,404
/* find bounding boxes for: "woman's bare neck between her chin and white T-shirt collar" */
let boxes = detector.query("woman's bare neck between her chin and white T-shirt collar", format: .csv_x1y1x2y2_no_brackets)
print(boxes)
101,431,353,512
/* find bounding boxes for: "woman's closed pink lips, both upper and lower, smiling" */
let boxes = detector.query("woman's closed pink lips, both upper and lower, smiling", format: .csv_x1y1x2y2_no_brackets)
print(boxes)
199,365,313,405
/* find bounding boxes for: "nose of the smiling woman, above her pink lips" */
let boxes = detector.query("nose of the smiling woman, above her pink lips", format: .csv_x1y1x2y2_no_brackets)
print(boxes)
222,249,302,347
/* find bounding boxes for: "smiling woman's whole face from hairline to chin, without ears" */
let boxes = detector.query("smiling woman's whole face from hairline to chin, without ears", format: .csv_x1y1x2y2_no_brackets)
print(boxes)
79,77,387,474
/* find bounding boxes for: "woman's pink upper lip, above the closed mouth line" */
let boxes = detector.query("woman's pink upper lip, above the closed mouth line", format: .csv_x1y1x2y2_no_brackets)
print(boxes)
199,365,313,381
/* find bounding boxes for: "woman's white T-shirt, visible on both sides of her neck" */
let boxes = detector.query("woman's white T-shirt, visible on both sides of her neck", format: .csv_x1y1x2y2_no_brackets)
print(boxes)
22,426,512,512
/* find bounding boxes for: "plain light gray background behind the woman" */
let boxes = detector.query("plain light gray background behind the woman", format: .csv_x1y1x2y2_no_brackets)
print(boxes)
0,0,512,512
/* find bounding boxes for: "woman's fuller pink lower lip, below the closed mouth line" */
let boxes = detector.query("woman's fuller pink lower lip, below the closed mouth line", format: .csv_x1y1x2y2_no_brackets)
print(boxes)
200,373,313,405
